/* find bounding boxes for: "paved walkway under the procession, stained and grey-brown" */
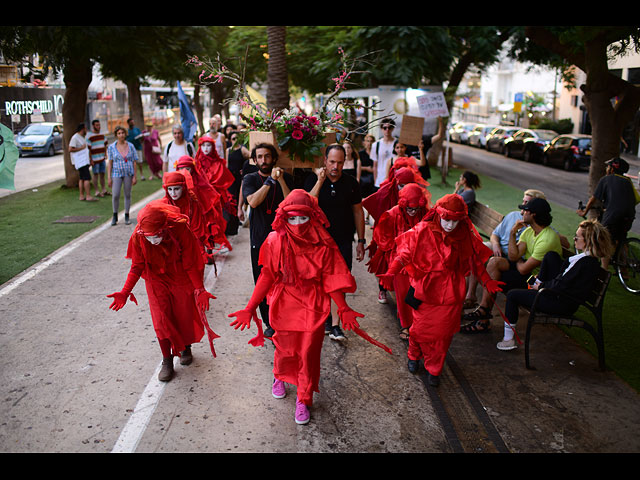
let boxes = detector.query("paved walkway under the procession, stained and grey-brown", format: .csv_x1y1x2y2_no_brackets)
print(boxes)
0,190,640,453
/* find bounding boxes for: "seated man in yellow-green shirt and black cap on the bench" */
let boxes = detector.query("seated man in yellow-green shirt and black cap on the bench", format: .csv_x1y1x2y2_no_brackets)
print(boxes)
460,198,562,333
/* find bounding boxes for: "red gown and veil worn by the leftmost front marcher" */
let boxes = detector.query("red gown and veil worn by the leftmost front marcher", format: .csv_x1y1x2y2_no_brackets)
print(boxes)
127,200,208,355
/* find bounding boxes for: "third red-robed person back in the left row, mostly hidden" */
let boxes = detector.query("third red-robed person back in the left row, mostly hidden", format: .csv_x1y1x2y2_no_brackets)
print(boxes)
176,155,233,250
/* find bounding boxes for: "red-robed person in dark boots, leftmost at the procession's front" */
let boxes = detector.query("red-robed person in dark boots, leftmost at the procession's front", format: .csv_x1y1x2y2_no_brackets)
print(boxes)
107,200,217,382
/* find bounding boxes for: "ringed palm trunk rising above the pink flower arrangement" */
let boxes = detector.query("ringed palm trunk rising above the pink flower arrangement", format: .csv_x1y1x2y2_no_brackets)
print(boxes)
267,26,290,110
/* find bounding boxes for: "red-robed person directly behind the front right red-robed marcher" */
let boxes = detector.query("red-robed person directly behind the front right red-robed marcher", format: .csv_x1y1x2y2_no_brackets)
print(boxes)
367,183,429,340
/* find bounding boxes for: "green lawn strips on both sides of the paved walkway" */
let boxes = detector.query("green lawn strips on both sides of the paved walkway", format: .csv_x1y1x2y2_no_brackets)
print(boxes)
0,168,640,391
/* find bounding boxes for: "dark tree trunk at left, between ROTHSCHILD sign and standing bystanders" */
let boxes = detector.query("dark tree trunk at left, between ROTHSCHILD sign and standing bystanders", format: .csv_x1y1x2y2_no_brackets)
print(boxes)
62,60,93,188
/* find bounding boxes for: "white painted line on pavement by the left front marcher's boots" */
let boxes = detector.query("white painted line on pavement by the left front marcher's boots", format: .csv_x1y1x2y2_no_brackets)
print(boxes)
111,248,226,453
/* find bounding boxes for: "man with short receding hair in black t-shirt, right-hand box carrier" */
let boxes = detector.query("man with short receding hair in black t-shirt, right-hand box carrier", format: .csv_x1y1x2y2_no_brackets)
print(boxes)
304,144,365,340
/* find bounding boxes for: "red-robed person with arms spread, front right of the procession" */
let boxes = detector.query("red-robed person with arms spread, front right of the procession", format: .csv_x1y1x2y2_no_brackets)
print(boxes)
380,194,504,386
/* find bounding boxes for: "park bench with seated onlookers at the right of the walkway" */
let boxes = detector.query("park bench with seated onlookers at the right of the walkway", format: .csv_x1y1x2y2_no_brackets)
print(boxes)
469,202,611,370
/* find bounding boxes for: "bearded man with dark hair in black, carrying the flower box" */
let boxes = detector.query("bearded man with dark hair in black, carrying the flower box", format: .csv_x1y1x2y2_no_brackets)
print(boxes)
242,143,293,337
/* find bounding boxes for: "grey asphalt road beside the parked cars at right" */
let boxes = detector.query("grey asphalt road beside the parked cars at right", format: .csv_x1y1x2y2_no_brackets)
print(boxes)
451,143,640,234
